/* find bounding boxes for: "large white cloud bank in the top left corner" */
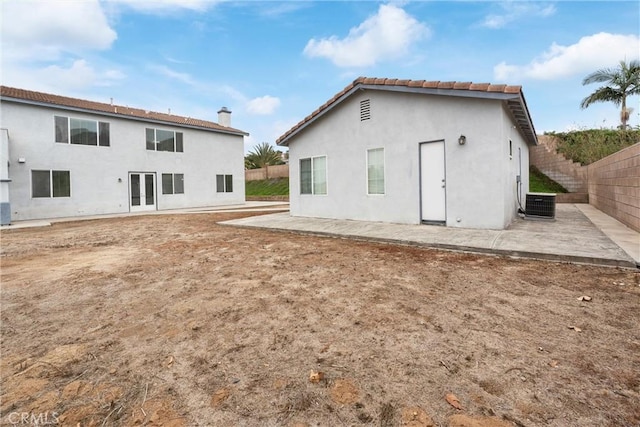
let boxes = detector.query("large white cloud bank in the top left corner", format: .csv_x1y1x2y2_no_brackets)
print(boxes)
0,0,125,93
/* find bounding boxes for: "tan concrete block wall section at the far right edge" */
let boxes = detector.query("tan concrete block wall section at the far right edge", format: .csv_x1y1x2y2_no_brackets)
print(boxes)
588,142,640,232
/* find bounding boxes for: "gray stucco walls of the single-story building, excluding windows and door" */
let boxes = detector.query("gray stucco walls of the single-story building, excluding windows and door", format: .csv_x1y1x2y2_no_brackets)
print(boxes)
289,90,528,229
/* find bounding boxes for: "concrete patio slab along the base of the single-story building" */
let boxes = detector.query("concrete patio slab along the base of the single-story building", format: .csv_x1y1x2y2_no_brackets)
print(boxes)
221,204,640,268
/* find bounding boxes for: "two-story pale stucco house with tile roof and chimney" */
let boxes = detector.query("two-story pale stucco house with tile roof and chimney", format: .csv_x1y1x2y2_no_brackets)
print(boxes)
0,86,248,224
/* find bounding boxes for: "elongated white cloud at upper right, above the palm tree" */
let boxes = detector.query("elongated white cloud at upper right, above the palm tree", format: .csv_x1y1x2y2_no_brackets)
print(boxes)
493,33,640,82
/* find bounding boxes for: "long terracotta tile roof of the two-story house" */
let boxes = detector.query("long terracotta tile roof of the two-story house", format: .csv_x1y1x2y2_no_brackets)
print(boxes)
0,86,248,135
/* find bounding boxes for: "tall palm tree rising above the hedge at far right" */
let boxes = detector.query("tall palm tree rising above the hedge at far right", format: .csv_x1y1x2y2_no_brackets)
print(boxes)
580,60,640,130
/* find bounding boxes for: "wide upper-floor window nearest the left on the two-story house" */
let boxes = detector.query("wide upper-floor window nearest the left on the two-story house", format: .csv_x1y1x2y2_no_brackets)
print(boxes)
54,116,110,147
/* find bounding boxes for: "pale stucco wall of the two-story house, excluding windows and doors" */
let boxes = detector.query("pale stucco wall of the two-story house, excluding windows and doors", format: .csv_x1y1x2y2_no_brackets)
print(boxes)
1,102,245,220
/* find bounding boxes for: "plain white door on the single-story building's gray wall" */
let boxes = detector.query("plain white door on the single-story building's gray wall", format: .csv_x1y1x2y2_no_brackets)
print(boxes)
420,141,447,223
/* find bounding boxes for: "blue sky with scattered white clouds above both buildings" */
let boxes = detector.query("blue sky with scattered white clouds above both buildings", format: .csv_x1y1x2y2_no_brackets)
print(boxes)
0,0,640,151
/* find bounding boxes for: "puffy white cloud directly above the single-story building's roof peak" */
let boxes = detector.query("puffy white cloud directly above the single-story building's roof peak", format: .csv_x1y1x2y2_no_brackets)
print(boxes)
304,4,430,67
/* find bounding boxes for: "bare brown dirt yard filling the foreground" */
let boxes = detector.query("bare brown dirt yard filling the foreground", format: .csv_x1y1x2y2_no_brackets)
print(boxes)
0,213,640,427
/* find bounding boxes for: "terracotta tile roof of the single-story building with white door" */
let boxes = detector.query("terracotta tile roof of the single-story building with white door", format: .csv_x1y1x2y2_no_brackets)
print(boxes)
276,77,537,145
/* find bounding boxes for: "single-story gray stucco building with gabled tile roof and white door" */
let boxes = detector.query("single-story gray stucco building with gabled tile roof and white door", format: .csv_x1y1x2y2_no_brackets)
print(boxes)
276,77,537,229
